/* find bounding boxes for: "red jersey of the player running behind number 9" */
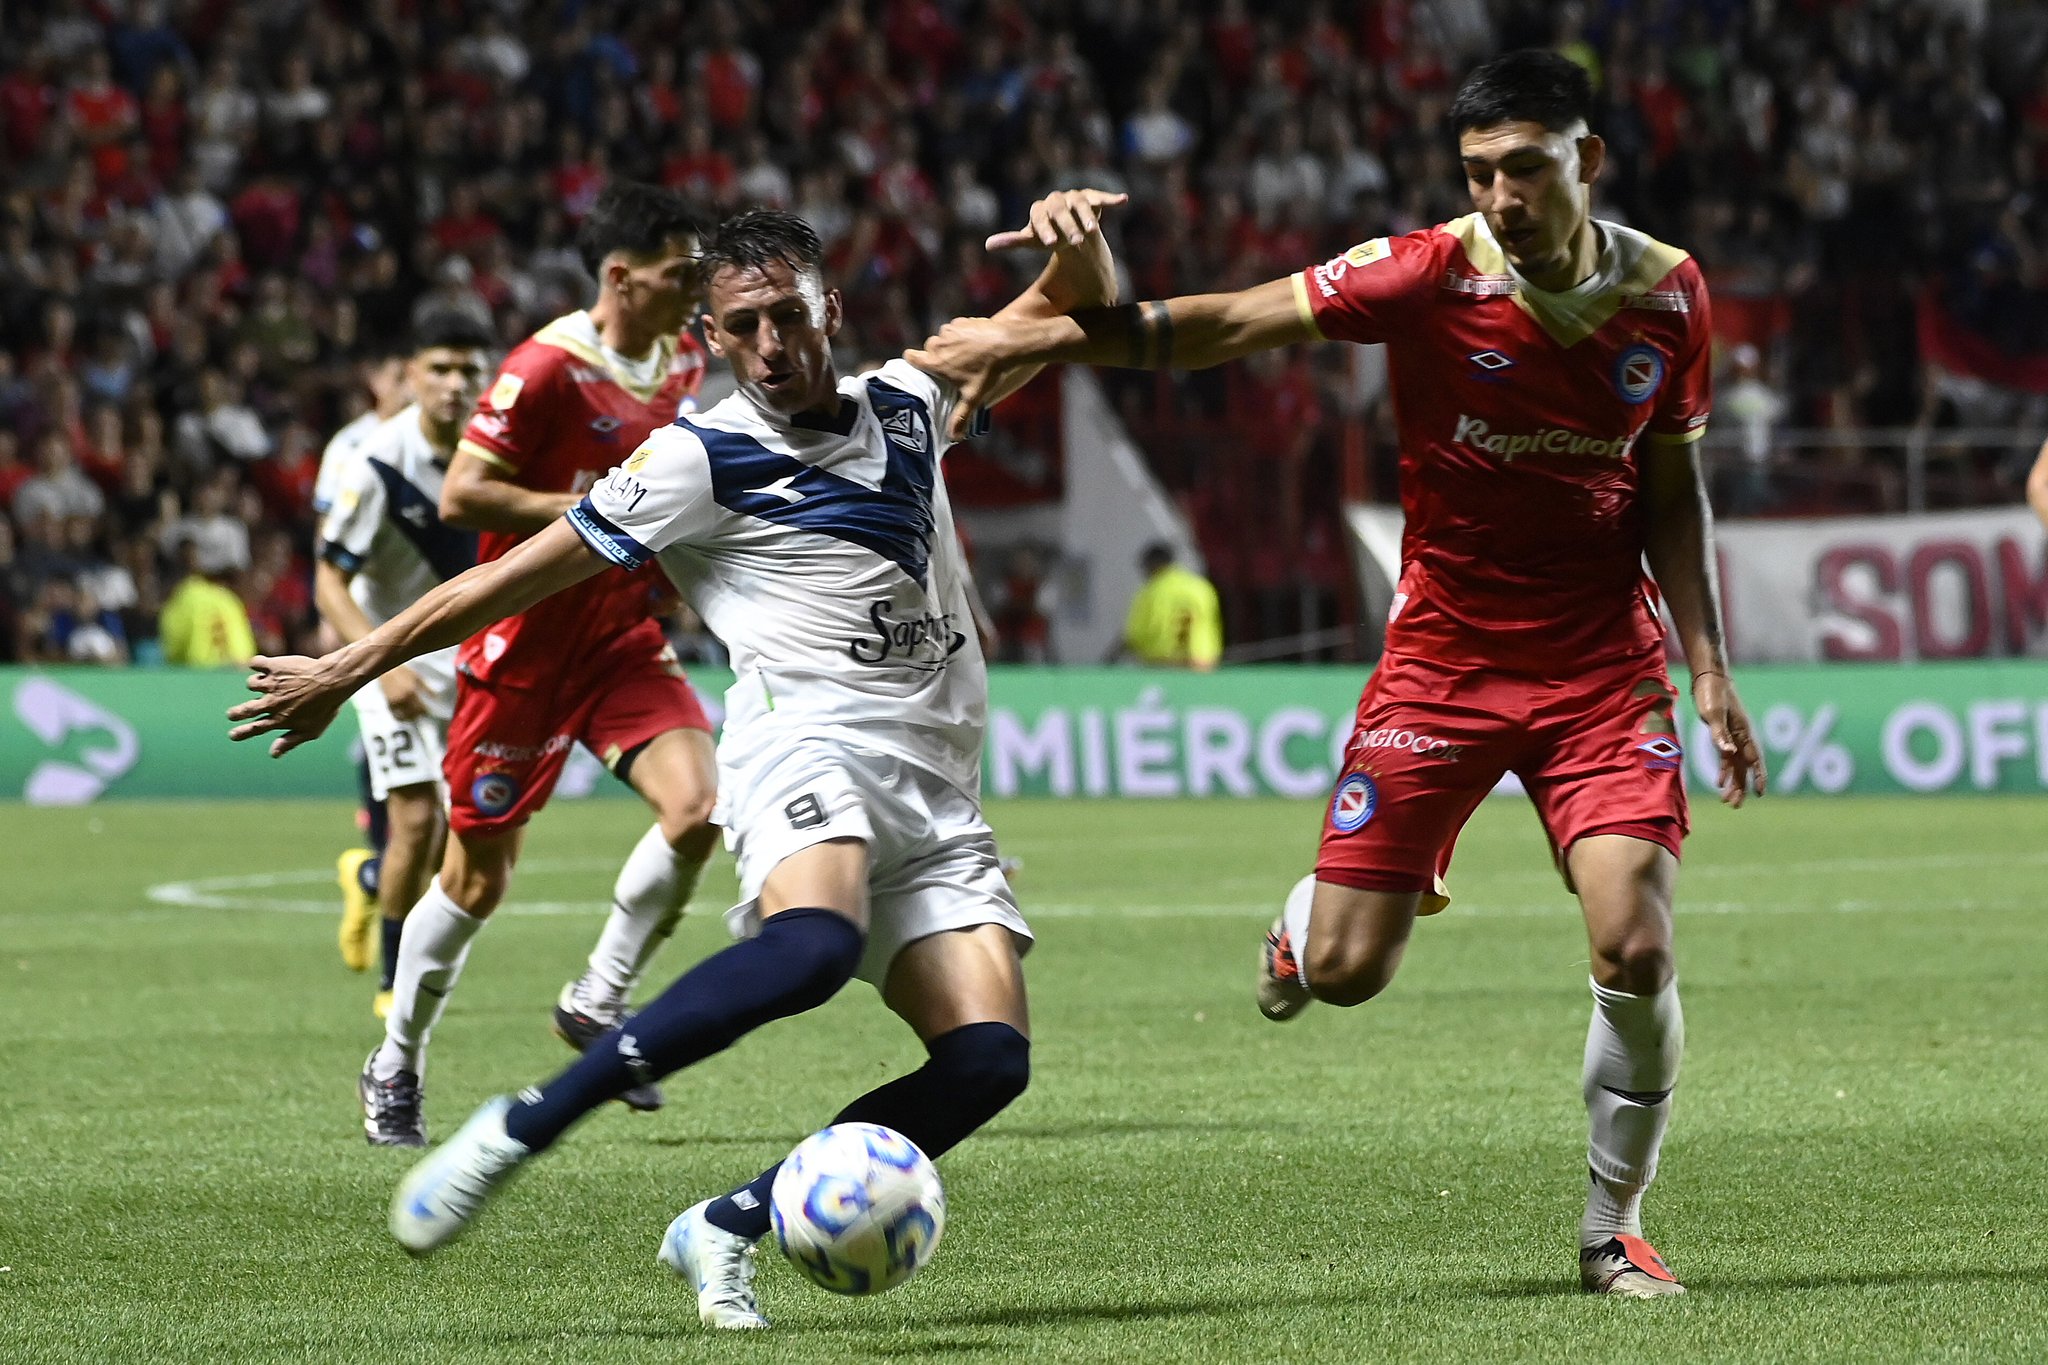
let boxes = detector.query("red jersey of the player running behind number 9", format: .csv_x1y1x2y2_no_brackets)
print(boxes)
457,311,705,686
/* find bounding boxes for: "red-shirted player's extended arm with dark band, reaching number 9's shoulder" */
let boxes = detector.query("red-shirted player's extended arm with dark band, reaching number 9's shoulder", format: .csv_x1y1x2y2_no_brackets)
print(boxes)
909,276,1321,444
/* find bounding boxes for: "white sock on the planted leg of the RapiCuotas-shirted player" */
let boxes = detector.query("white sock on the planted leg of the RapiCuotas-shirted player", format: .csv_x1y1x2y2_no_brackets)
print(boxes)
1579,980,1686,1246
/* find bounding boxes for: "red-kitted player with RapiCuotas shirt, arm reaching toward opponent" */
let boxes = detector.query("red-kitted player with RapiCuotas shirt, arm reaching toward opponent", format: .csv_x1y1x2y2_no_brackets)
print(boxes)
909,51,1763,1297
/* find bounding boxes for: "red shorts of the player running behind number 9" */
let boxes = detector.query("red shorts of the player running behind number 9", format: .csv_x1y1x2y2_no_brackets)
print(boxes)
442,620,711,835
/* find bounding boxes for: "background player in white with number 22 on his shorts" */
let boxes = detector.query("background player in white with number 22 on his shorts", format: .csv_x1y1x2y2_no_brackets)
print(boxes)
313,313,492,1146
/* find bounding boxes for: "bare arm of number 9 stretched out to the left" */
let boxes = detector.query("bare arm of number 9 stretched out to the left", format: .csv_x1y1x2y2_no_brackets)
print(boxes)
227,520,606,757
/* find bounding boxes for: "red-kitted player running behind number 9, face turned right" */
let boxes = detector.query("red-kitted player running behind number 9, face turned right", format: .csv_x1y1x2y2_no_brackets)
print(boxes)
360,184,717,1146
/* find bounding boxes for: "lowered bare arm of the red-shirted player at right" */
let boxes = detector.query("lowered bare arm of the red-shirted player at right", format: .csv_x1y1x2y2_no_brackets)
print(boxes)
1642,440,1767,806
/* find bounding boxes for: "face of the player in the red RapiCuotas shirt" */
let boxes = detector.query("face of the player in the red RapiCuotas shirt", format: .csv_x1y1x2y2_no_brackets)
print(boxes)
1458,121,1606,284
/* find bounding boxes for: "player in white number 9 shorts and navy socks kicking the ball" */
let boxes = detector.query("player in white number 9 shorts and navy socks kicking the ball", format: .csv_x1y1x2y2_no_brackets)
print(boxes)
229,190,1122,1328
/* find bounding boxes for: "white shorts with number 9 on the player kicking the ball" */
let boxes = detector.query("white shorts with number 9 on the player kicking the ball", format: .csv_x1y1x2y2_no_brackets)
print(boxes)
719,739,1032,988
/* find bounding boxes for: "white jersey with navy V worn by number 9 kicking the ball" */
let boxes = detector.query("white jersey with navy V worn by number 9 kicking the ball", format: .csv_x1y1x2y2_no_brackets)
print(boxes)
569,360,987,794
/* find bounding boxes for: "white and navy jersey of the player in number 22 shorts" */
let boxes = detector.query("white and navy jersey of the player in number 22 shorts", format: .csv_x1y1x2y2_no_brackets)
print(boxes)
319,403,477,706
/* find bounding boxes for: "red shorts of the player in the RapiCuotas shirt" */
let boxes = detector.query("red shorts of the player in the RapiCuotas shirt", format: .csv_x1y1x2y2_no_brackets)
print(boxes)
1315,655,1690,909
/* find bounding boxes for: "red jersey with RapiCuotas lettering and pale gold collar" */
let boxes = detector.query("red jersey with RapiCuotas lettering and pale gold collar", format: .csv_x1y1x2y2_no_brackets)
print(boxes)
1294,213,1710,677
